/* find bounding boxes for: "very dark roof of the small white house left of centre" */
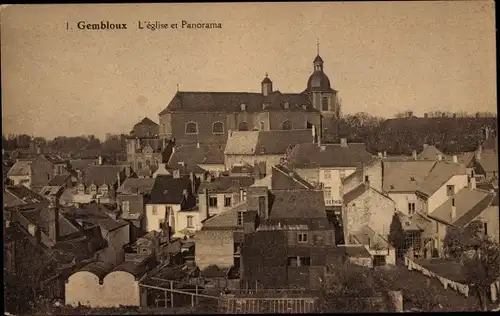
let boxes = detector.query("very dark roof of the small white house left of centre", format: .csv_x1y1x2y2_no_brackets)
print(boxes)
148,176,191,204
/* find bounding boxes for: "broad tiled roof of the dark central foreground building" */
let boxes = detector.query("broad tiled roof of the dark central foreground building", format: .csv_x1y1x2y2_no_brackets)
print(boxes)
269,190,326,219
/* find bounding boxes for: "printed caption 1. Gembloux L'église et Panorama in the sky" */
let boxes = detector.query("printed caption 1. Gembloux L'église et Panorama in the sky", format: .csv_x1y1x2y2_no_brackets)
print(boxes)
66,20,222,31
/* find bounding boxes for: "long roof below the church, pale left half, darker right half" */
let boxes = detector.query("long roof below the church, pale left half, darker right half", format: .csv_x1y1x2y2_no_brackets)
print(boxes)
224,129,313,155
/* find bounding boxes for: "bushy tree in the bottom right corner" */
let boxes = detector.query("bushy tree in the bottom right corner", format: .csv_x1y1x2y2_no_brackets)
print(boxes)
444,220,500,311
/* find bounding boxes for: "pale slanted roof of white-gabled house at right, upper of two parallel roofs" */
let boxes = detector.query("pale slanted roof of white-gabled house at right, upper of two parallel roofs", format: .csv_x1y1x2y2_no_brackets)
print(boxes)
418,161,466,196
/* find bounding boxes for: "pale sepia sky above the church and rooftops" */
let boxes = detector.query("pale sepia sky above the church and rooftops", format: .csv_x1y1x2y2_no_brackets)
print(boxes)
0,1,497,138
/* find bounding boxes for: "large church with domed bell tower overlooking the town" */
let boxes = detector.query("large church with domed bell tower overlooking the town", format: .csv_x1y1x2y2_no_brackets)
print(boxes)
159,54,340,144
